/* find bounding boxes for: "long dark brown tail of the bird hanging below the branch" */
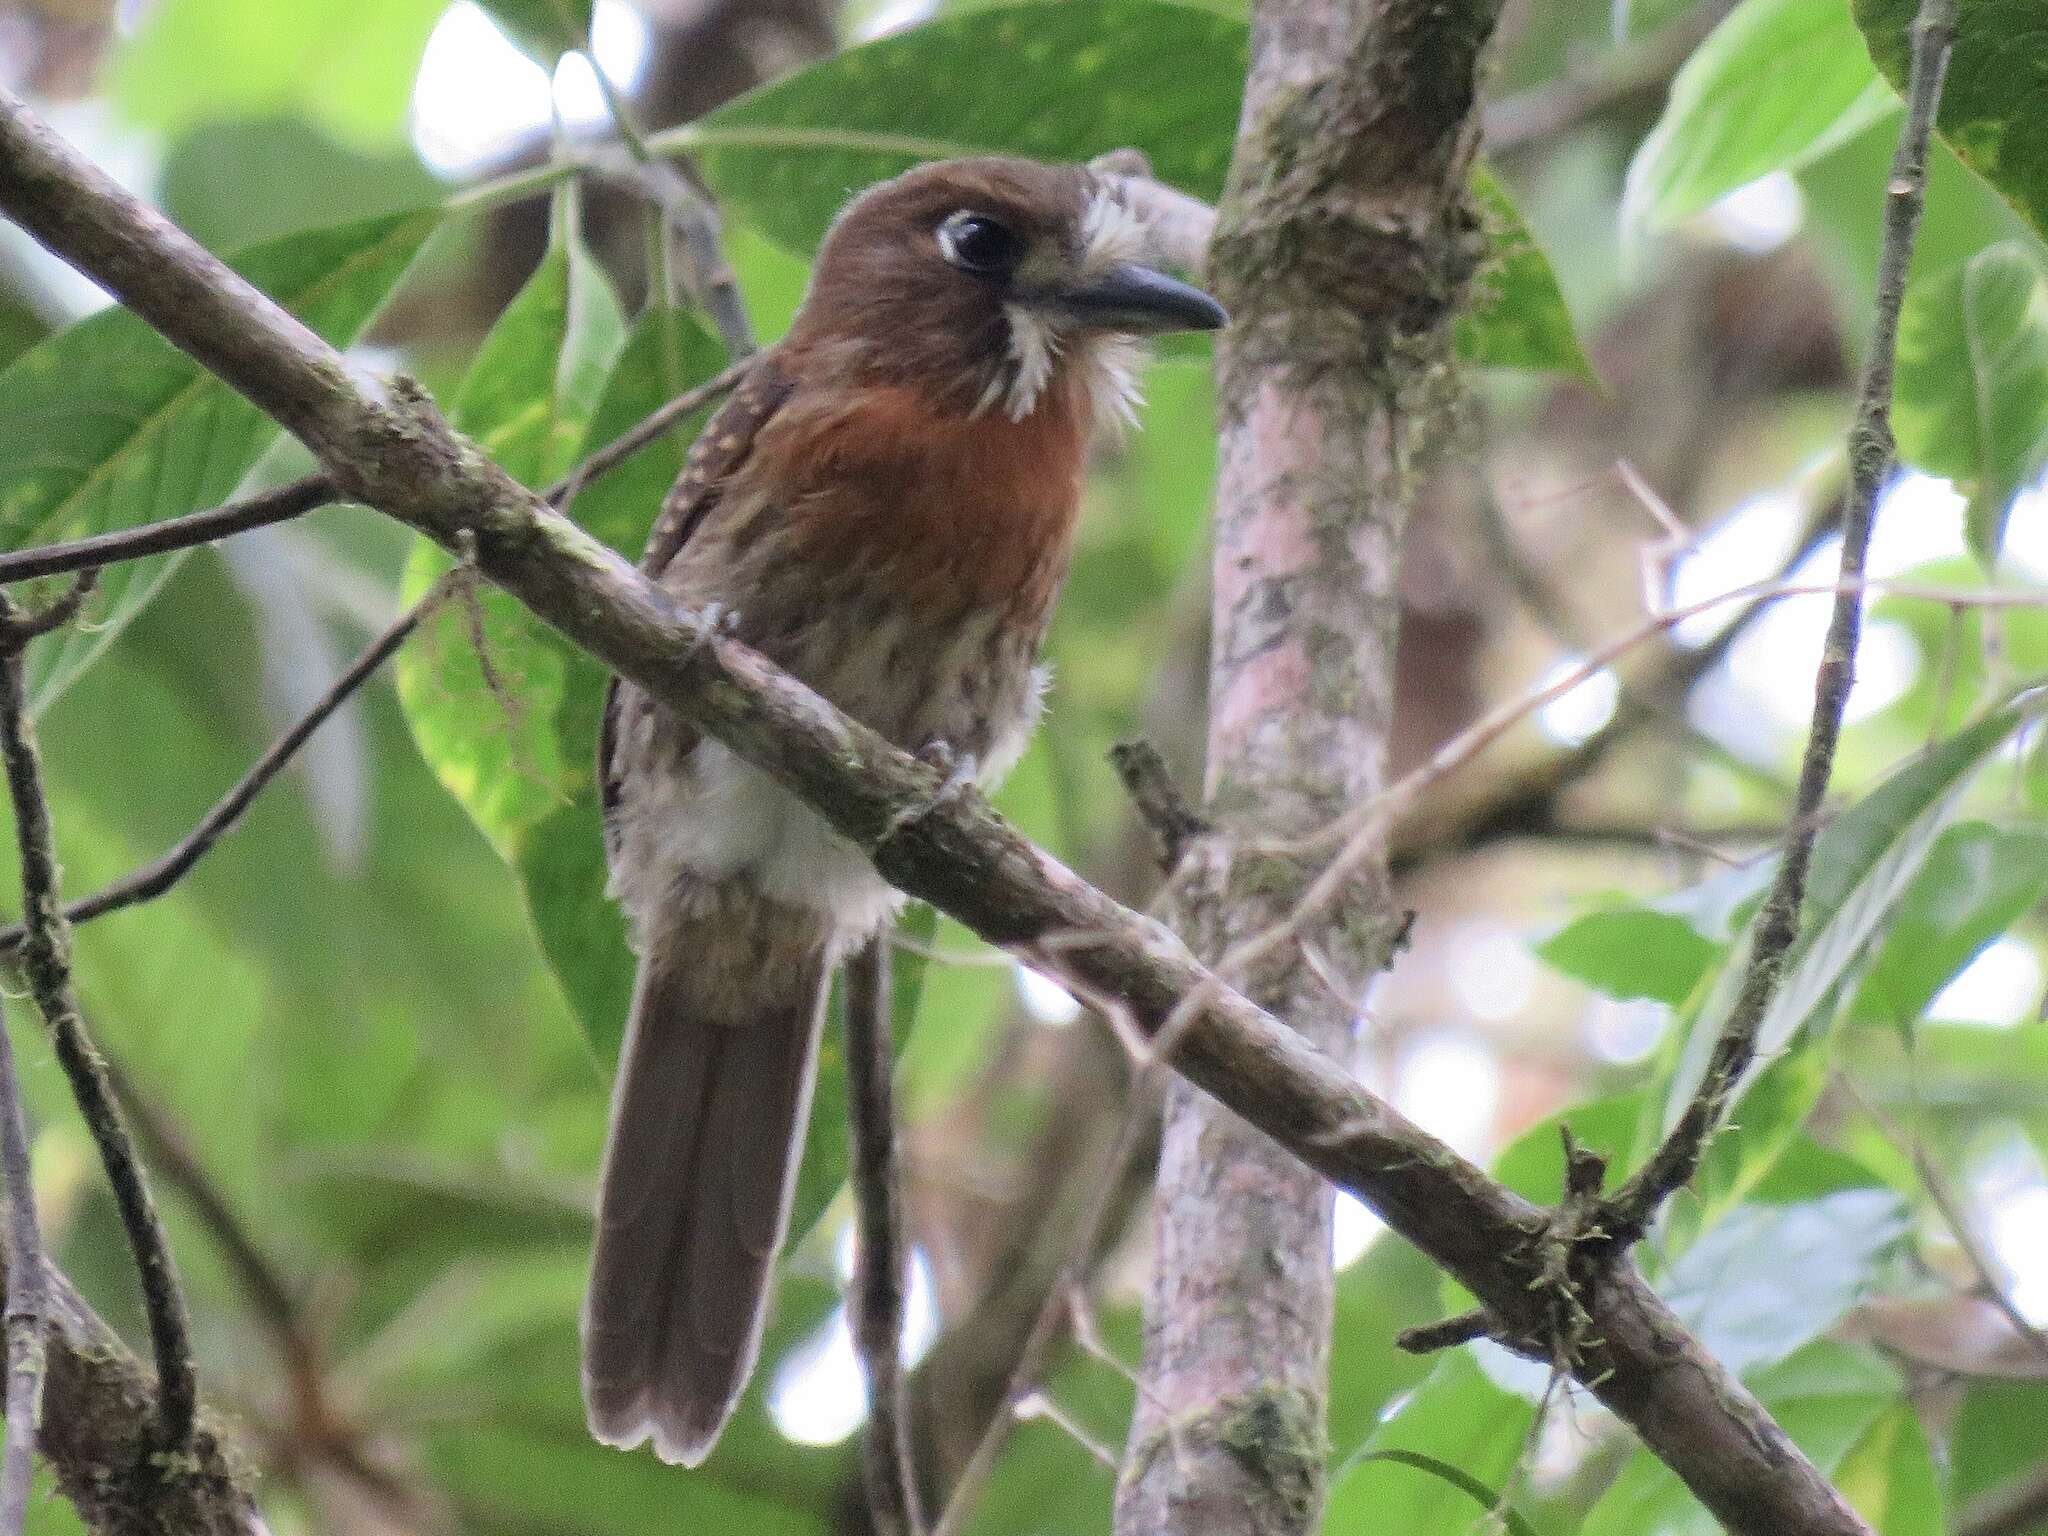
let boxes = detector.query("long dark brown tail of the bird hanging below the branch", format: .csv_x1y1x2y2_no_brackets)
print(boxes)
584,924,827,1466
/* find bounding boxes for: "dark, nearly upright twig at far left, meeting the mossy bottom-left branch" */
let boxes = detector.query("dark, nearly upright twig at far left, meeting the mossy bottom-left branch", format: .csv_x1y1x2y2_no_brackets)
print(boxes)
0,596,199,1450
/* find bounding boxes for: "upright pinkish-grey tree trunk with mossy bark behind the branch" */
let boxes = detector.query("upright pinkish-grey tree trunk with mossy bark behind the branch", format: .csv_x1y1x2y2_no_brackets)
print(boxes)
1116,0,1497,1536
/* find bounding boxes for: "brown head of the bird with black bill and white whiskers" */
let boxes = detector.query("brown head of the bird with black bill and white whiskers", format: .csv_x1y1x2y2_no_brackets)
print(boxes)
791,158,1225,420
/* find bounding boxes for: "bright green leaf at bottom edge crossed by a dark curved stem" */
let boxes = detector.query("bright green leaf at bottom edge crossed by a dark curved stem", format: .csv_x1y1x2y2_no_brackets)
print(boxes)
1323,1350,1536,1536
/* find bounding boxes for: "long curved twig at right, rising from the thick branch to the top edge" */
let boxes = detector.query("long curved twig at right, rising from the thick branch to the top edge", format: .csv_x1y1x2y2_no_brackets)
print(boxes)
1606,0,1956,1241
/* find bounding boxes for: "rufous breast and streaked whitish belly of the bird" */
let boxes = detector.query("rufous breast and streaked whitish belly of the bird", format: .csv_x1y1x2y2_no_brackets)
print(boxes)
612,387,1079,948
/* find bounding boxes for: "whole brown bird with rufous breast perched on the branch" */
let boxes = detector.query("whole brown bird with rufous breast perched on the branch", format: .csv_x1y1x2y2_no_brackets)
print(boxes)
584,160,1225,1466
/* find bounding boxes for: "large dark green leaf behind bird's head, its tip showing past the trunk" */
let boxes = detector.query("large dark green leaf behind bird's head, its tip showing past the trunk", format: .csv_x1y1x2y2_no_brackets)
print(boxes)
679,0,1591,377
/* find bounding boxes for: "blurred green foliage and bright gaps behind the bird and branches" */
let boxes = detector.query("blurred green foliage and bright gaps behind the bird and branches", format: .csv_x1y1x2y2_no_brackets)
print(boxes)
0,0,2048,1536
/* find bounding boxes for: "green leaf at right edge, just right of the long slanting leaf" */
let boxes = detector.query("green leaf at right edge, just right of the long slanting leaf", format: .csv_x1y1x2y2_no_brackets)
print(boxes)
1853,821,2048,1024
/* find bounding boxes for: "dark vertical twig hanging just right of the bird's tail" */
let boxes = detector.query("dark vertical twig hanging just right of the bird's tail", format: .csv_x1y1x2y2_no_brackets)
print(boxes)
846,938,924,1536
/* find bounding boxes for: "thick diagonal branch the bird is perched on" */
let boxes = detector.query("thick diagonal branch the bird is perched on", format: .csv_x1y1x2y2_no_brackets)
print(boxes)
0,92,1870,1536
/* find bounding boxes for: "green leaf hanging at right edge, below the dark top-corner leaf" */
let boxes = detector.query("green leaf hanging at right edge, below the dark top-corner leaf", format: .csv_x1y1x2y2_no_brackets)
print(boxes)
1892,242,2048,567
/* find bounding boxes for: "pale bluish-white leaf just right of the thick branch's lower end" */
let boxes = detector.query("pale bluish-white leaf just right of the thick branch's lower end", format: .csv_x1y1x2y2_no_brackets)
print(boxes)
1657,1188,1909,1376
